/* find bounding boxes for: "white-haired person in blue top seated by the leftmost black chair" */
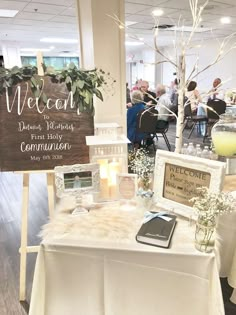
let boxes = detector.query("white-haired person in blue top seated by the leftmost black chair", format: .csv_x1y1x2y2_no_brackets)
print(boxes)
127,90,145,146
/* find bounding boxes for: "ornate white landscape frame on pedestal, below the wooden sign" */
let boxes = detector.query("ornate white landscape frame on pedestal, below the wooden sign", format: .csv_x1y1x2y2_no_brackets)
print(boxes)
54,163,100,198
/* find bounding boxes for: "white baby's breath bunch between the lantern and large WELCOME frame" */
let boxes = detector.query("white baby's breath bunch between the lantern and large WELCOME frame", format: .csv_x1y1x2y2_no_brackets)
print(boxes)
129,148,154,190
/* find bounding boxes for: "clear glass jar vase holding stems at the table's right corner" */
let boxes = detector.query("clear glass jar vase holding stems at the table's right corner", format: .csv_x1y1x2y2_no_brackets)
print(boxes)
195,215,216,253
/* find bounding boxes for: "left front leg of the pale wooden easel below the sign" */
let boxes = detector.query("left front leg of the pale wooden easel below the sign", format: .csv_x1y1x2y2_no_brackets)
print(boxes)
20,173,29,301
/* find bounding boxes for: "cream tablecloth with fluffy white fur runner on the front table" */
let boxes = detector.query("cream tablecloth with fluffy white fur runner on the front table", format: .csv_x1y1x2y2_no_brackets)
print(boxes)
30,206,224,315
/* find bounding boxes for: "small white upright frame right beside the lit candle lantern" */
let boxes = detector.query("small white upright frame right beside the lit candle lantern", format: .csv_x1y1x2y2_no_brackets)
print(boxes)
117,173,138,200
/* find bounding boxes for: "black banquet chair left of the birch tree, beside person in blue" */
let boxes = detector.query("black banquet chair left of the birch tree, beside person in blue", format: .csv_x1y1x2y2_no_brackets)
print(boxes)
136,106,171,151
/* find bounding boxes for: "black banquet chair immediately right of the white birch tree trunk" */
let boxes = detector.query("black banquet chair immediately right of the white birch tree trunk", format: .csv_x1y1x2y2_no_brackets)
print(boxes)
183,99,208,139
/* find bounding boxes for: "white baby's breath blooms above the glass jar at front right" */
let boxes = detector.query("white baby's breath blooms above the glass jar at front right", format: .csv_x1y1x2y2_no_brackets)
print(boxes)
190,187,236,226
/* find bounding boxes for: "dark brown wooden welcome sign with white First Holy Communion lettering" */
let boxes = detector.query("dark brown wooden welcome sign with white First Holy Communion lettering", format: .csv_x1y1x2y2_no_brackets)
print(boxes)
0,77,94,171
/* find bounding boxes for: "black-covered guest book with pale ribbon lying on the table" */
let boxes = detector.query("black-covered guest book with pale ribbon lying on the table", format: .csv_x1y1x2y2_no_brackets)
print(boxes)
136,213,177,248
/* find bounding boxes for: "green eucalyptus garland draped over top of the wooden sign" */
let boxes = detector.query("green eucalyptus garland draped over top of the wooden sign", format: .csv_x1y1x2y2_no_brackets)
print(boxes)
0,63,116,115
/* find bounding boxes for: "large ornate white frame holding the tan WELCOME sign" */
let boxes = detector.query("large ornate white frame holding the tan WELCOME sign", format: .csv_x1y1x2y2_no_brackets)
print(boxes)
153,150,226,218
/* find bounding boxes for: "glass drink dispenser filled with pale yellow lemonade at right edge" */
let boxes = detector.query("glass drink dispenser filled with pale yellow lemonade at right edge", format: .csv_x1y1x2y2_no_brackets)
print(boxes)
211,114,236,157
